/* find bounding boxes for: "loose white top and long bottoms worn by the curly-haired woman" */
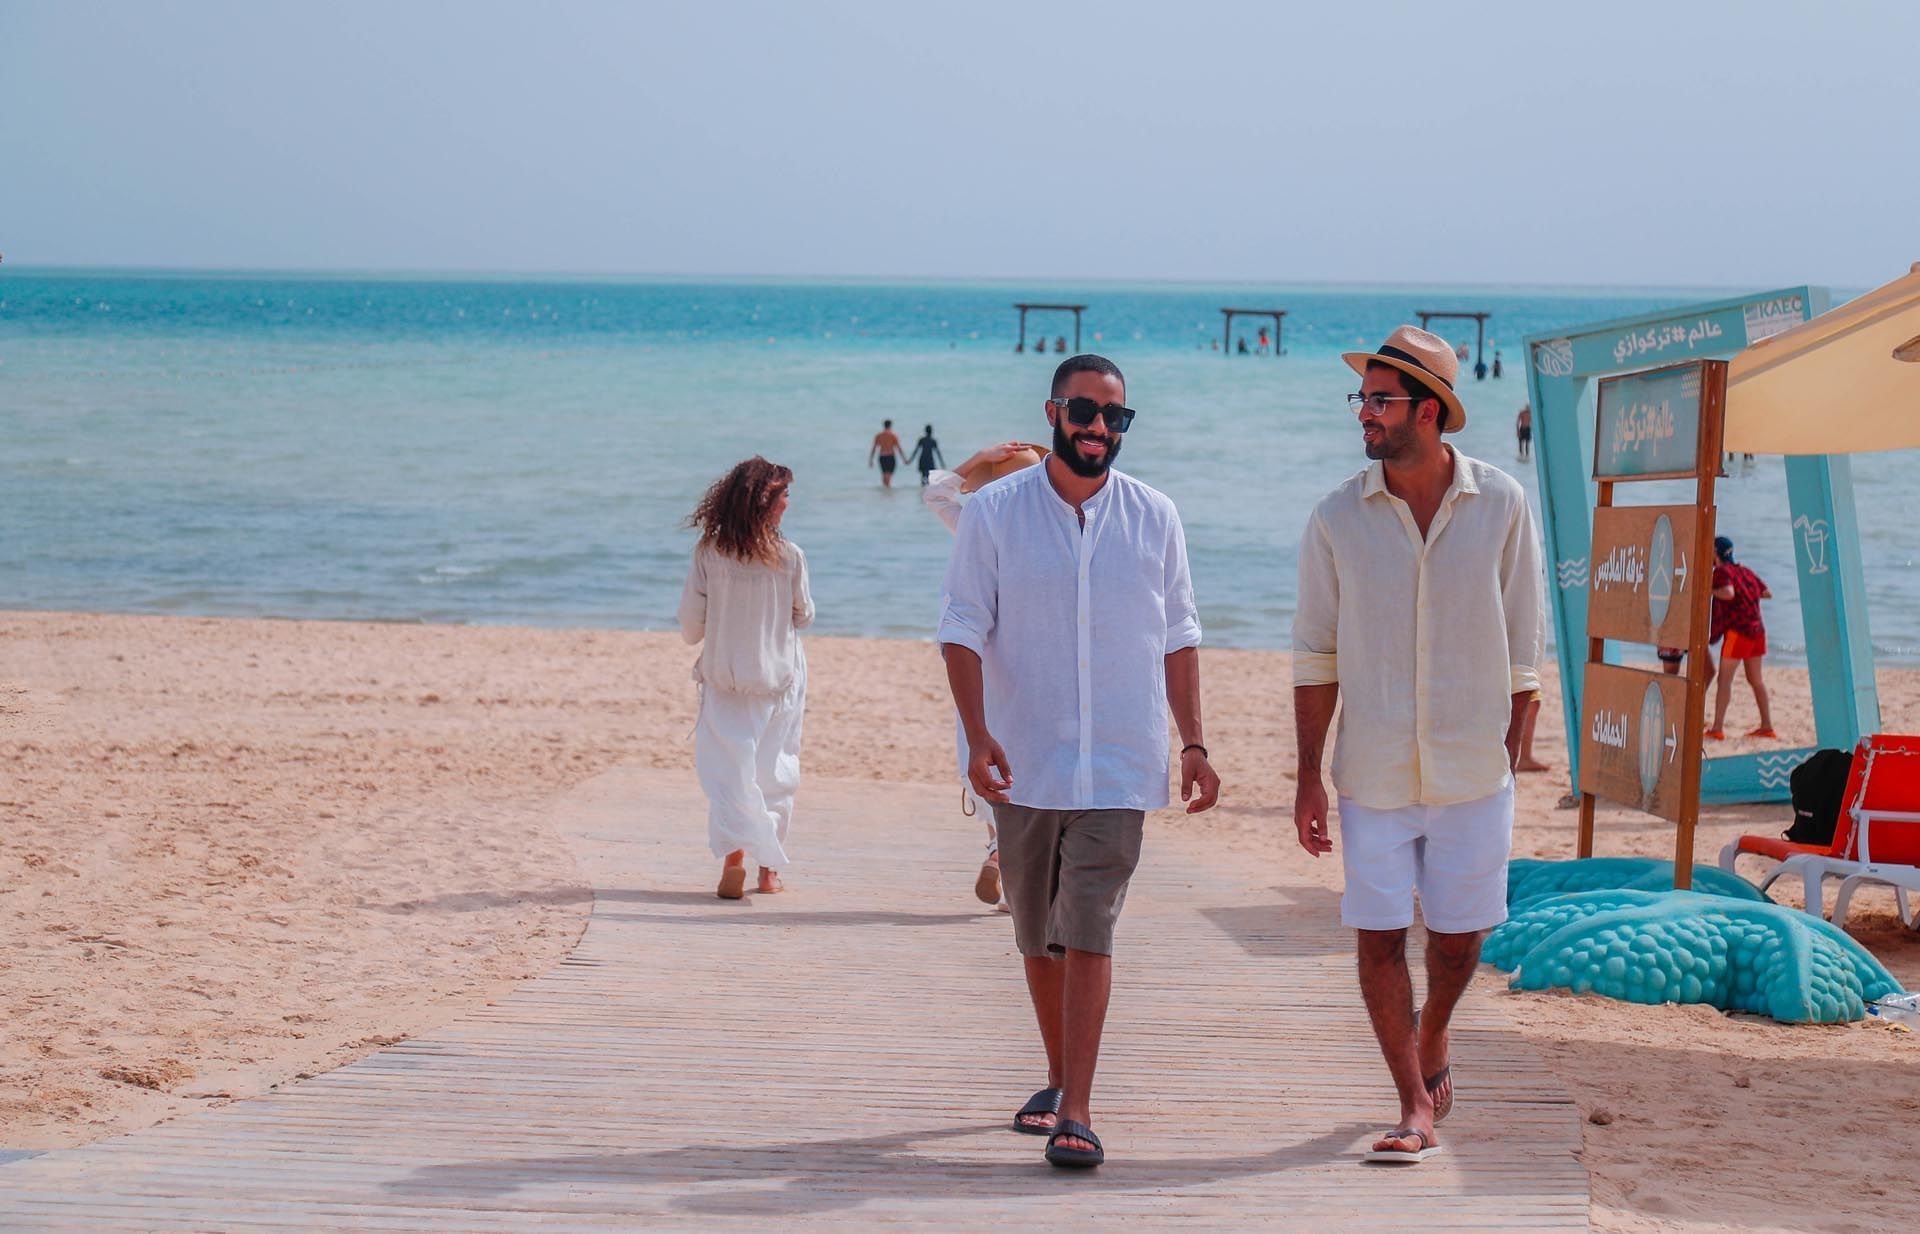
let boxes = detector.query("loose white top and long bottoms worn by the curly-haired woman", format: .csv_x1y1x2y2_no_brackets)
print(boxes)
680,541,814,869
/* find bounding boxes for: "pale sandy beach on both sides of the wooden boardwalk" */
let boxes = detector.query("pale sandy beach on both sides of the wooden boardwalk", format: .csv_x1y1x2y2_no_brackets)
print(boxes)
0,612,1920,1230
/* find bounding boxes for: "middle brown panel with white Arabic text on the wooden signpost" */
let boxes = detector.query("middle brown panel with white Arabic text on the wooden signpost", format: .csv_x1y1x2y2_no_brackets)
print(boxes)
1586,505,1713,647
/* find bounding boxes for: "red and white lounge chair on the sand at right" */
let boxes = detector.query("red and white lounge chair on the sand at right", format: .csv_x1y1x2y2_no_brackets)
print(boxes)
1720,733,1920,929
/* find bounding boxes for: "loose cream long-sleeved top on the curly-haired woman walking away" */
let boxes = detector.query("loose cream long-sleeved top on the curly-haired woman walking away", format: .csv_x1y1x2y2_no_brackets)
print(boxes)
680,539,814,697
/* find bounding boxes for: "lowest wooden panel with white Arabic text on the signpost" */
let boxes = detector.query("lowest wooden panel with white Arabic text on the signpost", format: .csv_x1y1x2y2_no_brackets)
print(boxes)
1580,664,1699,825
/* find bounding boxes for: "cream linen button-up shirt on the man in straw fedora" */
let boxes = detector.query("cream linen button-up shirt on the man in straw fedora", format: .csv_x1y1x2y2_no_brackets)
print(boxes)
1294,447,1546,810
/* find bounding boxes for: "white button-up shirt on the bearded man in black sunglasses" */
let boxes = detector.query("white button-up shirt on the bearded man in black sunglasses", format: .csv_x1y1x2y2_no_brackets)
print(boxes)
939,464,1200,810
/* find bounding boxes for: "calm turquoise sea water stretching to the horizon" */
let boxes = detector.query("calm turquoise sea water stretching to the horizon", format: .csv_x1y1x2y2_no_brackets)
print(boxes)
0,271,1920,662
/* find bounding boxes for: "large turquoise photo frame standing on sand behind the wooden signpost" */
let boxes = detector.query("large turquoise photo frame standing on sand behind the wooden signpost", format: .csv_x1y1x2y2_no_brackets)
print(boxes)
1524,286,1880,804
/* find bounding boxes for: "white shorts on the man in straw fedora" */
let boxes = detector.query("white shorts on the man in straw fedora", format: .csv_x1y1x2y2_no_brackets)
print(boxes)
1340,777,1513,935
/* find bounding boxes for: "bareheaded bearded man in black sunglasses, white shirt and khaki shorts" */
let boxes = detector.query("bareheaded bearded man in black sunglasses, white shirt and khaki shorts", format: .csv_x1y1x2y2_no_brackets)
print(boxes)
939,355,1219,1167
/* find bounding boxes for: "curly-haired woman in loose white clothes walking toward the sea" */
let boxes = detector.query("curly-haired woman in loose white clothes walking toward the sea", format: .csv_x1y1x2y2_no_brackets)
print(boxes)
680,455,814,900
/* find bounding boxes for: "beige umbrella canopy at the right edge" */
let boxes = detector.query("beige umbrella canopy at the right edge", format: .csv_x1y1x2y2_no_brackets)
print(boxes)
1726,263,1920,455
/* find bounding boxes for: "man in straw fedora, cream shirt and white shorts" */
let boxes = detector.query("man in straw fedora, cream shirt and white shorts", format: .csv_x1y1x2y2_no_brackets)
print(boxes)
1294,326,1544,1163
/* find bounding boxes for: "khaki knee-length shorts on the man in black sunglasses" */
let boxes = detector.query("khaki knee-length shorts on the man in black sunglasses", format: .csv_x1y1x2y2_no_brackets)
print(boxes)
993,804,1146,956
